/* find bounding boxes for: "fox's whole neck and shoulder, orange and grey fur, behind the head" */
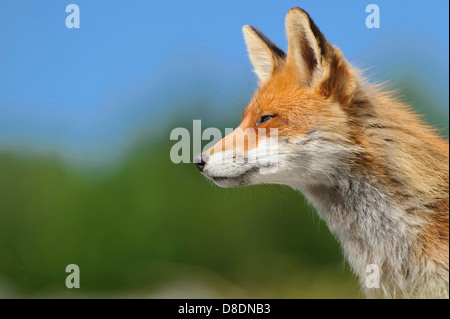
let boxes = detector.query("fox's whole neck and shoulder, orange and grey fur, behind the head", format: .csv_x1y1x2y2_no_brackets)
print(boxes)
292,84,449,298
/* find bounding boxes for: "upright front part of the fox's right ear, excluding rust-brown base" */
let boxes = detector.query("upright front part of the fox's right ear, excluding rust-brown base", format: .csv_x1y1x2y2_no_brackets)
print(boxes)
286,8,331,85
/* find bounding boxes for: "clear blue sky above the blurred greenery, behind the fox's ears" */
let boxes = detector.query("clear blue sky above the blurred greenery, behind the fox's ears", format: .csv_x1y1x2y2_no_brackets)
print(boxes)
0,0,449,168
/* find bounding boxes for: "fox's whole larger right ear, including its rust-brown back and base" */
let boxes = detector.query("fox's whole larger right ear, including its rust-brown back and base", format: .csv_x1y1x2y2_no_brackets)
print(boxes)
286,8,356,105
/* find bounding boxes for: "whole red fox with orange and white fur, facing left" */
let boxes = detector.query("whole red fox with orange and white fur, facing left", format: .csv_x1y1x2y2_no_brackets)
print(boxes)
196,8,449,298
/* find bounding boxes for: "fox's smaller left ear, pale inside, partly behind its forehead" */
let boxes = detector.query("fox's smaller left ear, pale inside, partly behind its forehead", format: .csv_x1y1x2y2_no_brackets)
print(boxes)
242,25,286,83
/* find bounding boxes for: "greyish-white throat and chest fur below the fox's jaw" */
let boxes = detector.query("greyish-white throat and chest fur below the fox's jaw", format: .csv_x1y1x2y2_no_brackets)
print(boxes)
303,176,448,298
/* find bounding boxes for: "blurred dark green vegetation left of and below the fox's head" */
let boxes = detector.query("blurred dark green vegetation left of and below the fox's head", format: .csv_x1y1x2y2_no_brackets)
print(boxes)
0,137,359,298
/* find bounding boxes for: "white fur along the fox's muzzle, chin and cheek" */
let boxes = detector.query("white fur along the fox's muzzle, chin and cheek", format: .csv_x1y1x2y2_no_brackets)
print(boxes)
203,131,356,189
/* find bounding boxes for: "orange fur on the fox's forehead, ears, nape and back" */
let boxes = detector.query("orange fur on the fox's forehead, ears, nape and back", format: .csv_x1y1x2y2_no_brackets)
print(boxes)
200,8,449,296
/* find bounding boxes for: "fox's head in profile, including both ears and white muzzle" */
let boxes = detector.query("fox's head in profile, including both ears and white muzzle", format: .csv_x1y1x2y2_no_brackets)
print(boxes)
196,8,358,188
